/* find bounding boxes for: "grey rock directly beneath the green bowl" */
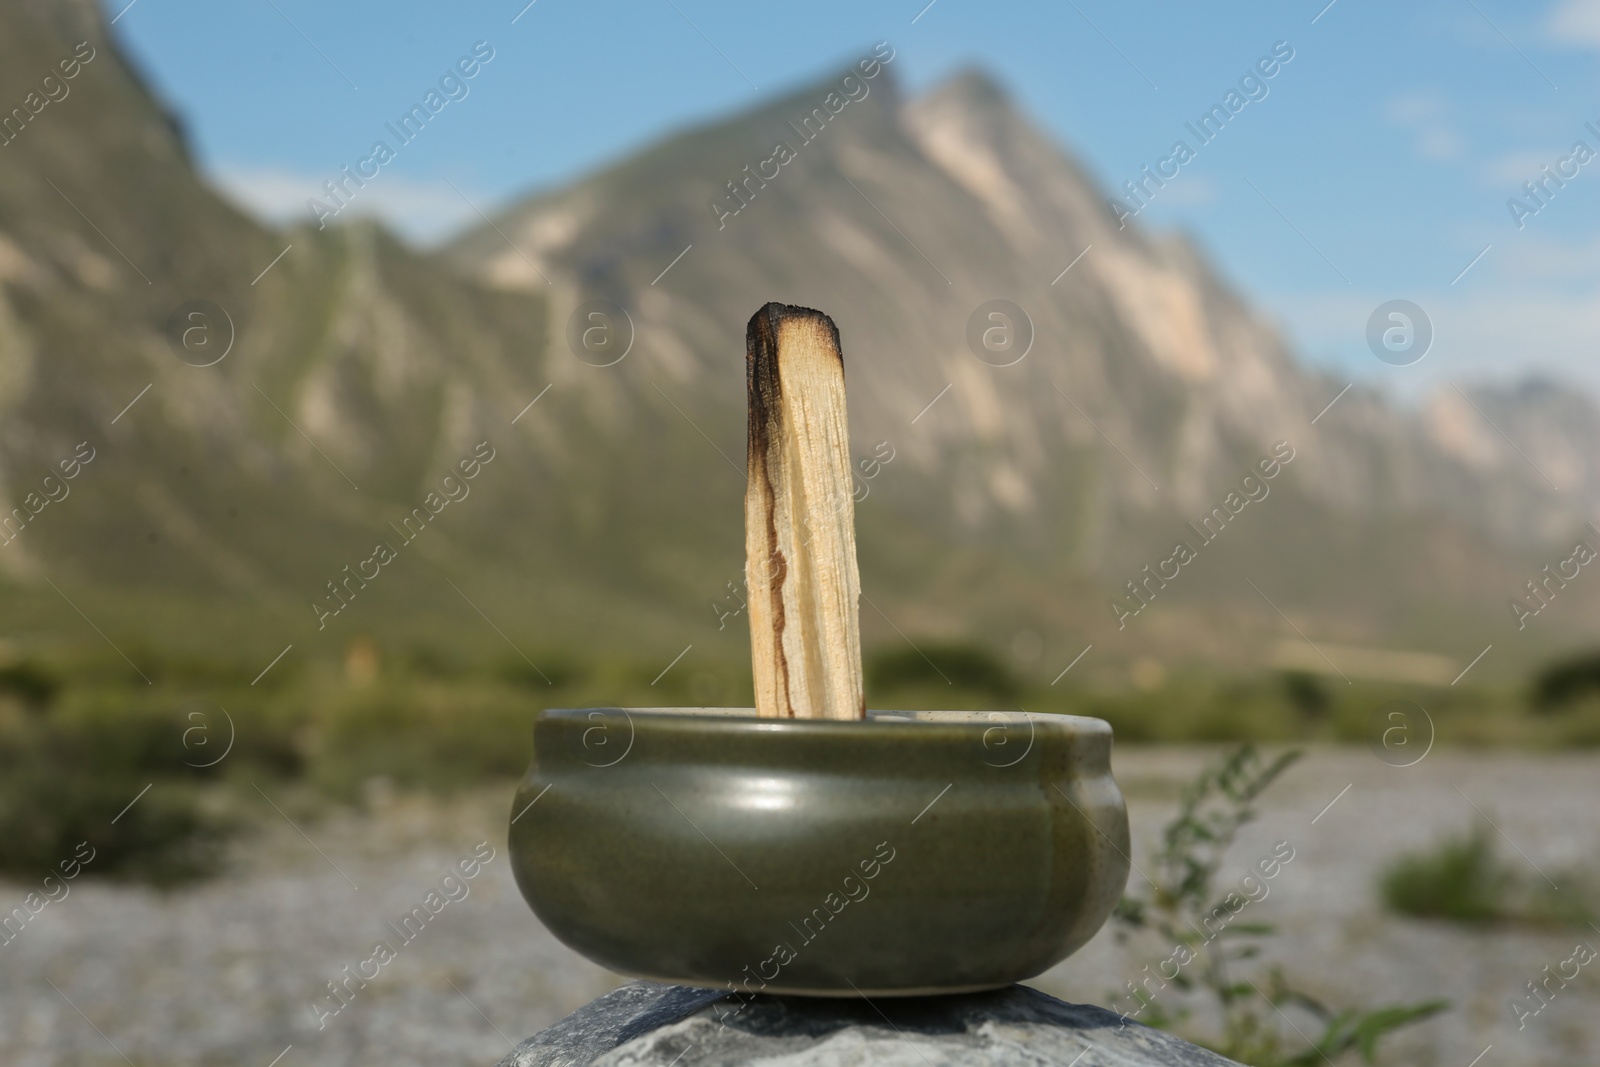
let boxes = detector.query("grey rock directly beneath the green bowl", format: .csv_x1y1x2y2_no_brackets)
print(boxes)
499,982,1238,1067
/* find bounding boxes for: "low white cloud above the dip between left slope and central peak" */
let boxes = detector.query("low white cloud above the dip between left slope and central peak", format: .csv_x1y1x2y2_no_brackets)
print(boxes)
210,163,483,245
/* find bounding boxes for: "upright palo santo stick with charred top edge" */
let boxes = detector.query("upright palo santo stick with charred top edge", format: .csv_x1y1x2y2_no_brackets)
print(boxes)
744,304,866,718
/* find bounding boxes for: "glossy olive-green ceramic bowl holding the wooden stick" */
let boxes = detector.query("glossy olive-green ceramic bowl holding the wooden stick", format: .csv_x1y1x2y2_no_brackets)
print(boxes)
510,709,1128,995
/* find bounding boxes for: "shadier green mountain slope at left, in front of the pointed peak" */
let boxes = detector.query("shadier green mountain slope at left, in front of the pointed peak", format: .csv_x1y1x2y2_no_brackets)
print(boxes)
0,0,736,664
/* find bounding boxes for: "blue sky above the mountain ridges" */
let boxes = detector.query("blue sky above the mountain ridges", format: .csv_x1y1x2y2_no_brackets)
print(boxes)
107,0,1600,397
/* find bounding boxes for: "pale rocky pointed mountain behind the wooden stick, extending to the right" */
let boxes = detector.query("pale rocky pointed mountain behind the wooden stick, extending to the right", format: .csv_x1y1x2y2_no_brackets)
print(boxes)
450,58,1600,675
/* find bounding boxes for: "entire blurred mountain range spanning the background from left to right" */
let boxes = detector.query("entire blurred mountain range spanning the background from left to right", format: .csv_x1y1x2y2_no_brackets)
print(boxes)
0,0,1600,687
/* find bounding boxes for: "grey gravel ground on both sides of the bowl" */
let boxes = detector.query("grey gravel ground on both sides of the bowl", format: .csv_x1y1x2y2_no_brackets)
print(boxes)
0,749,1600,1067
